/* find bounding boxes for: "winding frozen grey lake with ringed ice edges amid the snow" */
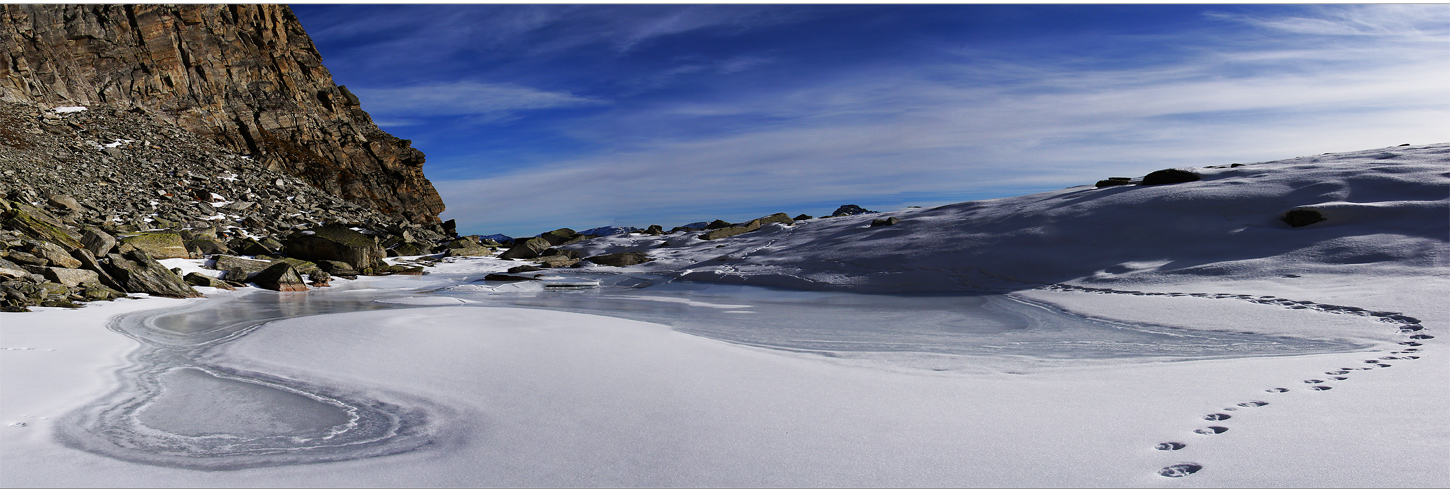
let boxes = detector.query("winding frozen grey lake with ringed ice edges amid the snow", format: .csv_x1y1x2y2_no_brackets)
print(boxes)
58,276,1363,470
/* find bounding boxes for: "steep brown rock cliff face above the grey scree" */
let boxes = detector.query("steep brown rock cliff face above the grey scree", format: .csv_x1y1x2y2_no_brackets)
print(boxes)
0,4,444,224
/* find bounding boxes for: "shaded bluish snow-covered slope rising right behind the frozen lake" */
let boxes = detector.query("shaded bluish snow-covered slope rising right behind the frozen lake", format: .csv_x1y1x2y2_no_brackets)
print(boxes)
570,144,1450,292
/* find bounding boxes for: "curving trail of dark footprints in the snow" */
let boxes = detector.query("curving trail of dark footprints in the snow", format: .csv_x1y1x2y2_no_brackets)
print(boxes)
1038,283,1436,479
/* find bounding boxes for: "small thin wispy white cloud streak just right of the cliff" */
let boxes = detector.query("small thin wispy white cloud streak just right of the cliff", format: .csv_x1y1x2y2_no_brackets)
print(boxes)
352,81,608,119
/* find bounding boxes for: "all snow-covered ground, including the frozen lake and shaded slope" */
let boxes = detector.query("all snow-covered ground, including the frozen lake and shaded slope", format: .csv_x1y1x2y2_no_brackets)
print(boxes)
0,144,1450,488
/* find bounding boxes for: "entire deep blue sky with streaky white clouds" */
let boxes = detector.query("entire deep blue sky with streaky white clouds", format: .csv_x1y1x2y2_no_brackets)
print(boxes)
293,4,1450,235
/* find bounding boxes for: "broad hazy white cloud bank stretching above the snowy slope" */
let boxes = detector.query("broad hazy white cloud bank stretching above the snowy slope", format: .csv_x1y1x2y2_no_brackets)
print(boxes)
435,5,1450,234
